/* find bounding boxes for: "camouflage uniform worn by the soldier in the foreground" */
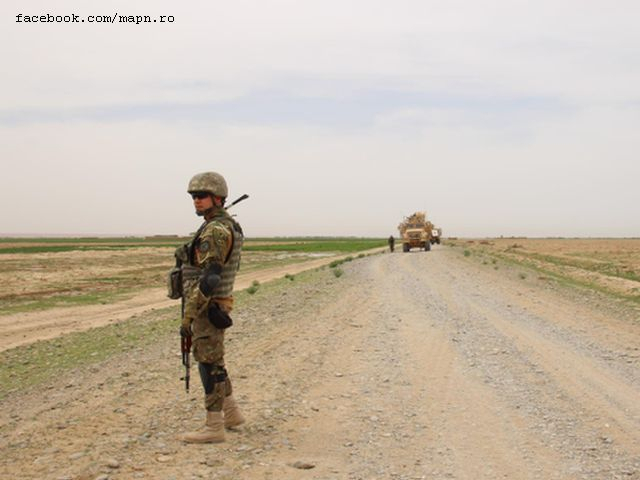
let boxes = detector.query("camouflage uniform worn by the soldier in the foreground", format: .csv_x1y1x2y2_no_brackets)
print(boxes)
183,208,244,411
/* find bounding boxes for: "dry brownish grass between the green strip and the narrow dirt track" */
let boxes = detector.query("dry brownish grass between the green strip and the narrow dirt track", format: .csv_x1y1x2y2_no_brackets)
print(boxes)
0,246,324,314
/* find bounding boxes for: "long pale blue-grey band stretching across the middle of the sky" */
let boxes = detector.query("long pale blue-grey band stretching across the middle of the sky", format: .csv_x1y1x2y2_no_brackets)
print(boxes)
0,80,571,130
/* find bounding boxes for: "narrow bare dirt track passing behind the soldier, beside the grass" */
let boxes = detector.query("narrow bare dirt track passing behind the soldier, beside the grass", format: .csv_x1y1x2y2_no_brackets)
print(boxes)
0,248,381,351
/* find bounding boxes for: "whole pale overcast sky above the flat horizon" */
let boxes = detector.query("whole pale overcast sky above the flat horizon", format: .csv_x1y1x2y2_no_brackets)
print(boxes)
0,0,640,237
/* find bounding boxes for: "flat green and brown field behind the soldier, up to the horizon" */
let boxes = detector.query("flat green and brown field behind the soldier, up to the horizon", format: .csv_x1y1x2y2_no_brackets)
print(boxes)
0,236,386,315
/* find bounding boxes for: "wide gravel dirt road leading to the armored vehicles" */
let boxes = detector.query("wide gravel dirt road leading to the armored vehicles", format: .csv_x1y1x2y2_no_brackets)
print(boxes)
0,247,640,480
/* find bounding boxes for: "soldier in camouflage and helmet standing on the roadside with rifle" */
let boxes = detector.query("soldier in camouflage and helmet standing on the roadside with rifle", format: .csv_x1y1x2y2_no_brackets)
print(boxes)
176,172,245,443
